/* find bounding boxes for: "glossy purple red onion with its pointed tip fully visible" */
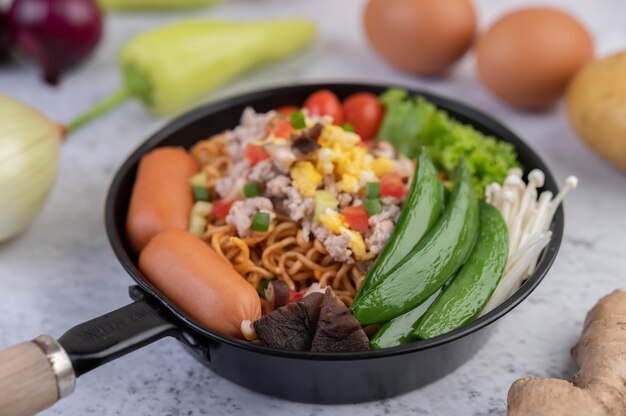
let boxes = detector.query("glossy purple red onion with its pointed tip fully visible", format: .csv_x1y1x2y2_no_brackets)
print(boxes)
9,0,102,85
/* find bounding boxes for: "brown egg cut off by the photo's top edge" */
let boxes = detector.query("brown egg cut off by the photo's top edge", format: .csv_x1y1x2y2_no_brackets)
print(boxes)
364,0,476,75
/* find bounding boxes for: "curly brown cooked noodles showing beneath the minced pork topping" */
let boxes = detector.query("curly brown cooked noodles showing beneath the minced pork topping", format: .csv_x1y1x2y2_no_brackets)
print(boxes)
191,135,365,314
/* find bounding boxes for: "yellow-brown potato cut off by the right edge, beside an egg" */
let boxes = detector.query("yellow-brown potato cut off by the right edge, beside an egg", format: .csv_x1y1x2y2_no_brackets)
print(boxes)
567,51,626,171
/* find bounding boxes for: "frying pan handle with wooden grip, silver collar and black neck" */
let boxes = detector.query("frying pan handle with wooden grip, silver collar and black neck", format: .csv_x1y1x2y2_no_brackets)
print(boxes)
0,288,184,416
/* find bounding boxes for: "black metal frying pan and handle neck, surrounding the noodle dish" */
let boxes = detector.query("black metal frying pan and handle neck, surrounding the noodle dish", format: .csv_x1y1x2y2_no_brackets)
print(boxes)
0,84,563,414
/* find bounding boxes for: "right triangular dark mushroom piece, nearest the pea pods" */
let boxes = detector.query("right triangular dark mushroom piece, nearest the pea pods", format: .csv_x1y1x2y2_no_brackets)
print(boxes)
311,288,370,352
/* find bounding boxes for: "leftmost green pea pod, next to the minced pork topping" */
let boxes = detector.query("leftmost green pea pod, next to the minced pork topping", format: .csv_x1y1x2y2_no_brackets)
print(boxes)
355,149,443,301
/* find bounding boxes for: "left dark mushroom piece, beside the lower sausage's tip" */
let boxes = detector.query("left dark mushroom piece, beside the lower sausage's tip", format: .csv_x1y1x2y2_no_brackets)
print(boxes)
254,293,324,351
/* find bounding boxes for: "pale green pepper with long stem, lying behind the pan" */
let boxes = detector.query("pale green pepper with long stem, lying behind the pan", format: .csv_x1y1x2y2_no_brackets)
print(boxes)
68,19,315,131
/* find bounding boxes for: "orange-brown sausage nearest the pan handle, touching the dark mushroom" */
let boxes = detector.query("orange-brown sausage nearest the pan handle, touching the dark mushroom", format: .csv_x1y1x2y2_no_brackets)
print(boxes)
139,230,261,338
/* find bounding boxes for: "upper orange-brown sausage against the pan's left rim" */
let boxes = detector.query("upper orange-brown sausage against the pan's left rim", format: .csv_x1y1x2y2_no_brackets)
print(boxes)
126,147,198,251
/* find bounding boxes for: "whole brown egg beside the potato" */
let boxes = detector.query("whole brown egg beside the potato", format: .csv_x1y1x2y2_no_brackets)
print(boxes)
476,8,593,110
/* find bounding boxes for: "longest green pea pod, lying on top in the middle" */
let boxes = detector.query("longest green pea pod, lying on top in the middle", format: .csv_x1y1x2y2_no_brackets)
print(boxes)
352,162,478,325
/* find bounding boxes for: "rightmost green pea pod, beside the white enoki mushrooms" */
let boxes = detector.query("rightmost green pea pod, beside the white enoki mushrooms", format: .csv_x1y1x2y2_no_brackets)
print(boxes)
415,204,509,339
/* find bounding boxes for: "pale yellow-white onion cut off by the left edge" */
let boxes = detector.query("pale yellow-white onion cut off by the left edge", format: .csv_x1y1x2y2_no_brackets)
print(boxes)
0,95,66,242
